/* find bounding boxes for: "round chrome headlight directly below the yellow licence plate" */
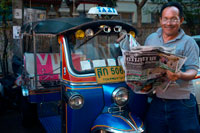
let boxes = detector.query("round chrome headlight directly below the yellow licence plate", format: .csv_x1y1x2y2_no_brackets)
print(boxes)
112,87,129,106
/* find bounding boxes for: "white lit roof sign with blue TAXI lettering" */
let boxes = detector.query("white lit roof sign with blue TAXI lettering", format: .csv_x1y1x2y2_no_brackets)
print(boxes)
88,7,118,15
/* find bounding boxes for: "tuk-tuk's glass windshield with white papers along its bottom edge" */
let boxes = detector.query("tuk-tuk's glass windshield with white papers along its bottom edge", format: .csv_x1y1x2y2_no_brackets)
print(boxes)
69,34,122,72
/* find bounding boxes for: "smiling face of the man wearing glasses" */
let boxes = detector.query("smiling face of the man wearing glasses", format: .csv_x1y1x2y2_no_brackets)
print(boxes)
160,7,184,36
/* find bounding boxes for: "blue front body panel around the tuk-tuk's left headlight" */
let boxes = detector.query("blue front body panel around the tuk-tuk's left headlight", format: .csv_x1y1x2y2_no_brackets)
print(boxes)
67,86,104,133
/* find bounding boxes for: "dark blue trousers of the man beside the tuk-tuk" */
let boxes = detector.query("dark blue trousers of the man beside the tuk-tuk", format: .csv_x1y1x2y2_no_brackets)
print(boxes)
145,94,200,133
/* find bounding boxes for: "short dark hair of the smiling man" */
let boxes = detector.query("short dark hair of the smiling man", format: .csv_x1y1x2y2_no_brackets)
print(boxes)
160,2,183,18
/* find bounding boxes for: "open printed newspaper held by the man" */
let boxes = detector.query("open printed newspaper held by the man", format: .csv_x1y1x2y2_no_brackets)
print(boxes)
119,35,186,94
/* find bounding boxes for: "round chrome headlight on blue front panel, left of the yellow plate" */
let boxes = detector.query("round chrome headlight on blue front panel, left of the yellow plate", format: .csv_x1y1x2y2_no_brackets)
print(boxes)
68,94,84,109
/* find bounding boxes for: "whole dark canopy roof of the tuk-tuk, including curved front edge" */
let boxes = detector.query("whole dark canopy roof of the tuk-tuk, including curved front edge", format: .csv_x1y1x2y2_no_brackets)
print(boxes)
21,17,137,35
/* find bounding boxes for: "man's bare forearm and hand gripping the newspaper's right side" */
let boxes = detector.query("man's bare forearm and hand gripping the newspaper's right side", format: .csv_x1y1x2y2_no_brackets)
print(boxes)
167,69,197,81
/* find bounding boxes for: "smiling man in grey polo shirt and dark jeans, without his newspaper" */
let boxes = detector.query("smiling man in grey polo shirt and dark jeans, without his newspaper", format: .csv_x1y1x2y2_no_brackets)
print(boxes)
145,2,200,133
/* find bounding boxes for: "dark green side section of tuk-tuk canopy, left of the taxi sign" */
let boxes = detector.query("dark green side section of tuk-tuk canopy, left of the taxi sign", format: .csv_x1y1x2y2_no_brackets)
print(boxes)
21,17,93,34
